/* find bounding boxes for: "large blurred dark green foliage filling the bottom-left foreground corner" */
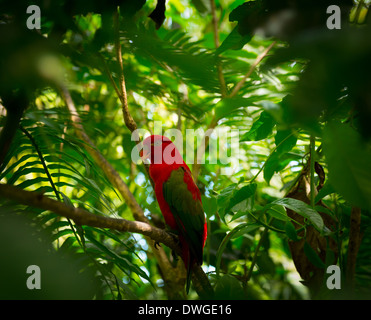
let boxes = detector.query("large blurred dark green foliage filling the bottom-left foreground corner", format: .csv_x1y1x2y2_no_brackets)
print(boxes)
0,211,101,300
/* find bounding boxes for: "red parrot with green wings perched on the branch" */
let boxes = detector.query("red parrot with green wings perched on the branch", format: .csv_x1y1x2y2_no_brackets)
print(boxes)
141,135,207,294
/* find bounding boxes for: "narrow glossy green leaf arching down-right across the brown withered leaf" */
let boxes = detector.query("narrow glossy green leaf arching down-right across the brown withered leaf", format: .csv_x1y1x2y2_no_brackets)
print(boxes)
271,198,325,234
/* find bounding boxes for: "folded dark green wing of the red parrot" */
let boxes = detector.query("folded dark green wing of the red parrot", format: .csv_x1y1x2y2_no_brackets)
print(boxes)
163,167,205,264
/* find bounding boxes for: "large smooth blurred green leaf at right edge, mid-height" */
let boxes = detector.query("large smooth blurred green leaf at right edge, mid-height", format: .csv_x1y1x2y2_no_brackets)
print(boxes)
323,123,371,210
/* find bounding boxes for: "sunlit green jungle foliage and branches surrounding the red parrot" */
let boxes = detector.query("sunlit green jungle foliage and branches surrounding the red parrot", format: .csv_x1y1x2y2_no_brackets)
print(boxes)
0,0,371,300
